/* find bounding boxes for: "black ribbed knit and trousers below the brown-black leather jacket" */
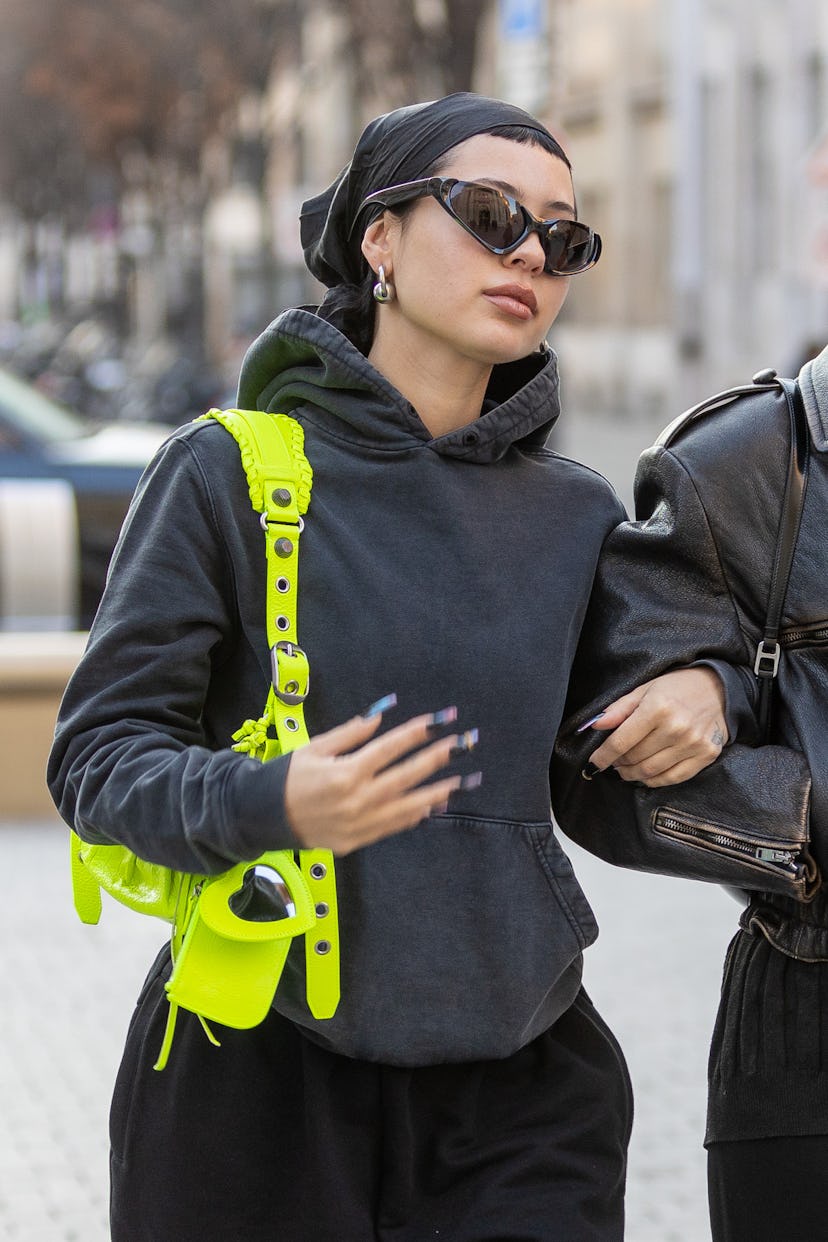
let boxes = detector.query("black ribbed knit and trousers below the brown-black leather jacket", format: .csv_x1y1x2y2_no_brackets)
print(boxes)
705,933,828,1242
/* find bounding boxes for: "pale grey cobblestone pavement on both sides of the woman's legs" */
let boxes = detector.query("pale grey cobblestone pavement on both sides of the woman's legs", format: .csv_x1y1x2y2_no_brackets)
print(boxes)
0,822,736,1242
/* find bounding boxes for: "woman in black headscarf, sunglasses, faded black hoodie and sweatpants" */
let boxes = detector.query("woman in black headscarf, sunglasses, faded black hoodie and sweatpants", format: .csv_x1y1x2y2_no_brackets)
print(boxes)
50,94,721,1242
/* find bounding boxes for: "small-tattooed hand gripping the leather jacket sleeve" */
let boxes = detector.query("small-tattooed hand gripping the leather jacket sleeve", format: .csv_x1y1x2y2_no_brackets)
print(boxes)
583,668,727,789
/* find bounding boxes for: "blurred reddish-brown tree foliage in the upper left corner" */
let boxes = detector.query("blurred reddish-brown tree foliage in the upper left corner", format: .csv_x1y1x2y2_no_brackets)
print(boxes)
0,0,281,219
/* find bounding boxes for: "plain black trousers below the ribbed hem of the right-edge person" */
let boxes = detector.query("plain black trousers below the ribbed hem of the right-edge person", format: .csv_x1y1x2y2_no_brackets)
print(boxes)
708,1134,828,1242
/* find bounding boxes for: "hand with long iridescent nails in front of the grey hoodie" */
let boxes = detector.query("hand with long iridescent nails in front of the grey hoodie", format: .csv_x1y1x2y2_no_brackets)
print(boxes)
284,708,479,854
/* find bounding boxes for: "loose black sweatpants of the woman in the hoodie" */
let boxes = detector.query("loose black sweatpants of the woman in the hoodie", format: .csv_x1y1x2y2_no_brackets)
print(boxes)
110,954,632,1242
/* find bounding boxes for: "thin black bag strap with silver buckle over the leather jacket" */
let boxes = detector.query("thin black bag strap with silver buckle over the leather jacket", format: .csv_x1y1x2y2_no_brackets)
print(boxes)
754,370,811,741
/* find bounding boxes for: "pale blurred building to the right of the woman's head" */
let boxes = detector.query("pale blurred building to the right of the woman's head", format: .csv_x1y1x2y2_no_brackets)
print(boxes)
528,0,828,428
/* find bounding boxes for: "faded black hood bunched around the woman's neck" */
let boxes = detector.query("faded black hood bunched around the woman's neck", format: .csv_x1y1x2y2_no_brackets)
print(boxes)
237,309,560,462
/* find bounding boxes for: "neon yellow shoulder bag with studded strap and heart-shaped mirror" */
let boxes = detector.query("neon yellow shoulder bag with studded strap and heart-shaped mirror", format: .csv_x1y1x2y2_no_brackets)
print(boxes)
71,410,339,1069
